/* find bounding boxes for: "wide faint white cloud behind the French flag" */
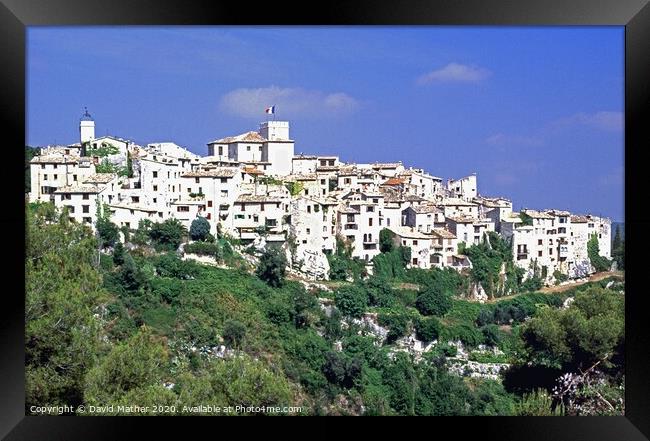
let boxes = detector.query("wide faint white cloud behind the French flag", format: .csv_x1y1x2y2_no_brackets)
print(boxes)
219,86,359,118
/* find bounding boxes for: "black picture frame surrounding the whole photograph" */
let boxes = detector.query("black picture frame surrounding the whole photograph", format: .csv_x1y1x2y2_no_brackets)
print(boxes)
0,0,650,441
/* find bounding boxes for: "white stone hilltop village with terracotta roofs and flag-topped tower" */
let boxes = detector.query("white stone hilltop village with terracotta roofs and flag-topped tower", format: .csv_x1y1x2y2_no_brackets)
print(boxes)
28,111,611,284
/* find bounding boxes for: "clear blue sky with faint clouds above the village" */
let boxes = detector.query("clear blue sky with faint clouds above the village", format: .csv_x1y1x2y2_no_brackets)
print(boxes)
26,26,624,221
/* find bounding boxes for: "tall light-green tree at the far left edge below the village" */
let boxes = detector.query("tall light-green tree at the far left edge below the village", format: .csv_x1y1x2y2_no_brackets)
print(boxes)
25,204,107,412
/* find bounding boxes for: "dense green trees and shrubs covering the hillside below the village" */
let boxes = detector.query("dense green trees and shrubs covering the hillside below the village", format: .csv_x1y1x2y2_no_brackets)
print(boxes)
25,204,623,415
